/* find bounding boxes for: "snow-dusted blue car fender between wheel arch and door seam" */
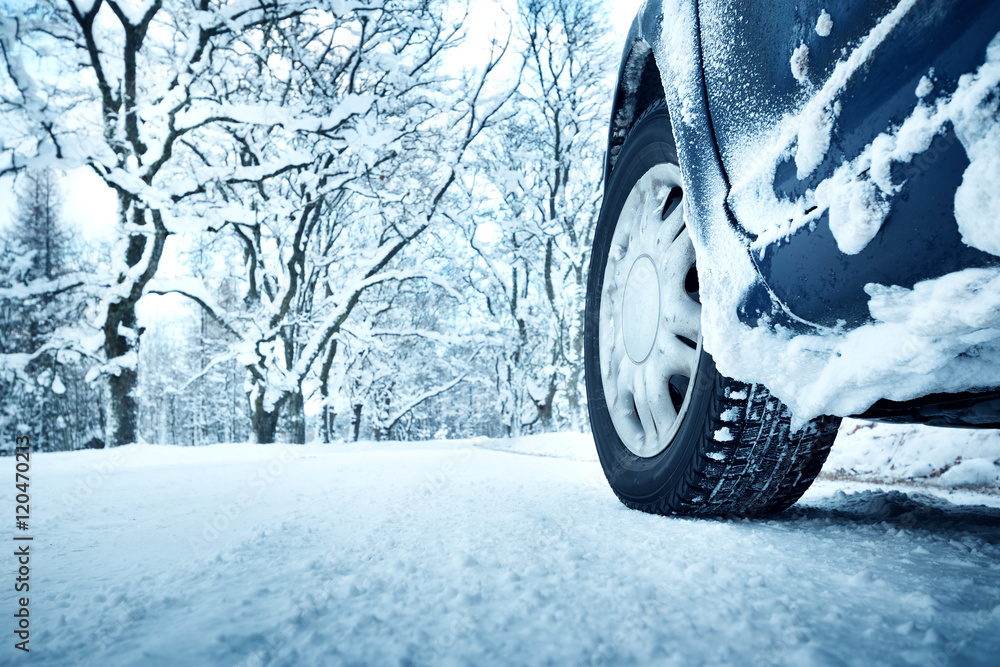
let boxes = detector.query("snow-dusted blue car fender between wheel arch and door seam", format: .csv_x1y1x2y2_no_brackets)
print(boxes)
605,0,798,386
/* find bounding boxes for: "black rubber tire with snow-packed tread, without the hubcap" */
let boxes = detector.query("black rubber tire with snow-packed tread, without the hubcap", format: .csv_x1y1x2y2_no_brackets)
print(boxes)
584,102,840,516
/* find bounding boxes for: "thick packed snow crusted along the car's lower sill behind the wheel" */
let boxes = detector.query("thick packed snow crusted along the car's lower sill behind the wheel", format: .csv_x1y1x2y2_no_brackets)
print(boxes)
703,269,1000,422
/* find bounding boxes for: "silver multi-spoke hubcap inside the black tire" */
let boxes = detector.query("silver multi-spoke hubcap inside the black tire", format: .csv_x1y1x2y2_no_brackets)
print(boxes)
599,164,701,457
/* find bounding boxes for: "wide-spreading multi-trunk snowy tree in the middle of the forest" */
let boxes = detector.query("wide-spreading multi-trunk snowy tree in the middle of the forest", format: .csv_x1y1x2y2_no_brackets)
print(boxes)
144,0,512,442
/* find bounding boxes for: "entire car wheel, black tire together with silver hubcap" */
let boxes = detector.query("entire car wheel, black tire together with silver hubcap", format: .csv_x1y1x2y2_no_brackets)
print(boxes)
584,102,840,516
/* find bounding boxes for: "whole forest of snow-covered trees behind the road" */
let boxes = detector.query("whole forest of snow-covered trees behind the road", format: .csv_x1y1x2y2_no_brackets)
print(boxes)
0,0,620,450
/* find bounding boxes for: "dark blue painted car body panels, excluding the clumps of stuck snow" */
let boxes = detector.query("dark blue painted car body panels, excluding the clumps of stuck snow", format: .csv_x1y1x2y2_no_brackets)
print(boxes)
606,0,1000,427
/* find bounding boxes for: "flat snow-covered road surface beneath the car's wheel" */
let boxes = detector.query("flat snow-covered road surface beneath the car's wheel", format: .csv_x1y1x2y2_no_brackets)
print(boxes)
0,435,1000,666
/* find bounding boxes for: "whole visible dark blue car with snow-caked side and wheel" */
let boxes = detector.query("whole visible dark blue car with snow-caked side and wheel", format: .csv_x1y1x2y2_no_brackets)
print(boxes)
585,0,1000,516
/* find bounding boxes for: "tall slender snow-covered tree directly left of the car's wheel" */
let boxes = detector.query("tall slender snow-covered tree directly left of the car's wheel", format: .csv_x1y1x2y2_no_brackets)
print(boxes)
467,0,614,433
